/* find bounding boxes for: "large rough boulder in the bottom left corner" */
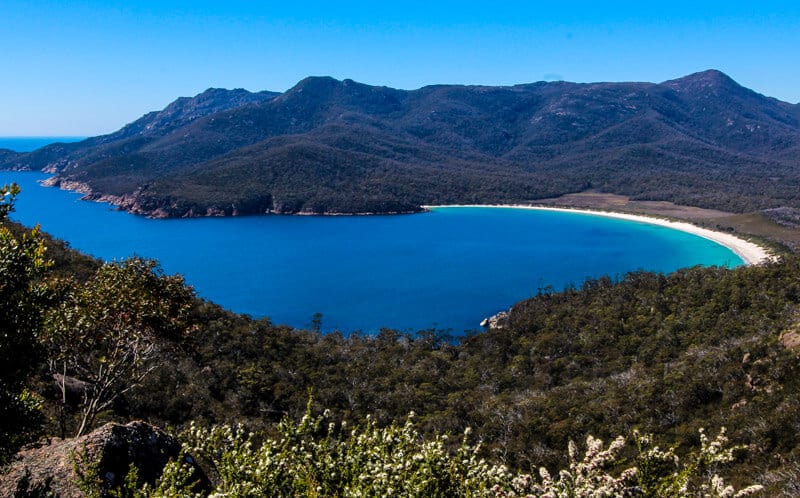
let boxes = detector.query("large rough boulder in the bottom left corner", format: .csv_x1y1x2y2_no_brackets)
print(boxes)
0,421,210,498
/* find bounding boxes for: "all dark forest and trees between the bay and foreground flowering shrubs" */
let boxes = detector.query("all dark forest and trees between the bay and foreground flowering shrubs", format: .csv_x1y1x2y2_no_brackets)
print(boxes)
0,183,800,496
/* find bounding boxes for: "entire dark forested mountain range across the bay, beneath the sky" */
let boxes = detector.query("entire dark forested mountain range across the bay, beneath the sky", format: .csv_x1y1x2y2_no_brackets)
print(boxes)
0,70,800,216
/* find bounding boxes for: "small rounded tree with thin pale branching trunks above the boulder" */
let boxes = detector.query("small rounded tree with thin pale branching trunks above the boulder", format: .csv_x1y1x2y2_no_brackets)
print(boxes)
46,258,194,436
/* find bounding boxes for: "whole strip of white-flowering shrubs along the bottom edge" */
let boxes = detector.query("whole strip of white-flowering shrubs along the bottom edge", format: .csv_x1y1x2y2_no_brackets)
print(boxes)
98,406,761,498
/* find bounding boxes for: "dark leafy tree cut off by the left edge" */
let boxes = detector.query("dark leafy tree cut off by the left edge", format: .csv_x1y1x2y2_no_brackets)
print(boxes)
0,184,49,463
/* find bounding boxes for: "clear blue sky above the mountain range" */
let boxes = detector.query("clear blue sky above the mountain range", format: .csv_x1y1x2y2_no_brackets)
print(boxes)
0,0,800,136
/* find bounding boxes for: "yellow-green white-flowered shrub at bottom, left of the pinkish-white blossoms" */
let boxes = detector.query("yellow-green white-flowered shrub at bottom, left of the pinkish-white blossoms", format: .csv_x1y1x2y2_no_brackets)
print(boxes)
174,408,505,497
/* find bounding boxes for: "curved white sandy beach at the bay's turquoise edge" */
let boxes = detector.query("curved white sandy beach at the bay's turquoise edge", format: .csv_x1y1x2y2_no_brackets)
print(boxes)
422,204,775,265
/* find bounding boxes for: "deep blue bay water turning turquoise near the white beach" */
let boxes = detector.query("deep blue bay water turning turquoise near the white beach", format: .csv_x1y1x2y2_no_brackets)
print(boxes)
0,172,741,335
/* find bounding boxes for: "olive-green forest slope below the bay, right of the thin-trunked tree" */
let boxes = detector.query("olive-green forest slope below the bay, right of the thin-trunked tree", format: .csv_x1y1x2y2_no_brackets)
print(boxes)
114,256,800,494
